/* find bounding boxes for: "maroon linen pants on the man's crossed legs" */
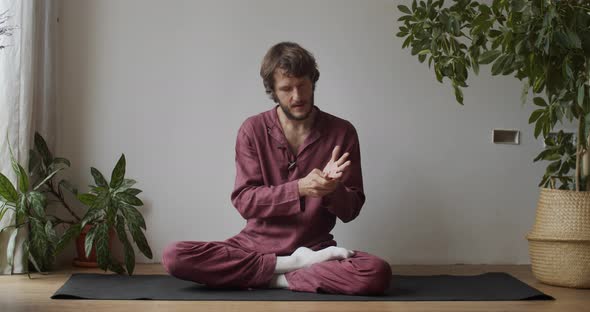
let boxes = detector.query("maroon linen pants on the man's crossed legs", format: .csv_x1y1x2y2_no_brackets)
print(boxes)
162,241,391,295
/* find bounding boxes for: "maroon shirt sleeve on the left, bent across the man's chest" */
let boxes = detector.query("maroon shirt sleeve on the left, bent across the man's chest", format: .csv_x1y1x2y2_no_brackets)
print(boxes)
231,125,302,219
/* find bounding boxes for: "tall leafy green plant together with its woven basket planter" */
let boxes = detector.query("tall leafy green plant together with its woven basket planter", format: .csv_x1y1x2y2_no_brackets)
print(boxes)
397,0,590,288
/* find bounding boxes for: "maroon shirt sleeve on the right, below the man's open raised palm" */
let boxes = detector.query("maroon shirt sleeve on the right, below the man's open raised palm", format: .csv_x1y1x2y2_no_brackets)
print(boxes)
322,125,365,223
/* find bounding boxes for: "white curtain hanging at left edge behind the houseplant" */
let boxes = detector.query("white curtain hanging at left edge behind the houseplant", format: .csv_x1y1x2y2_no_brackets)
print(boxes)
0,0,58,274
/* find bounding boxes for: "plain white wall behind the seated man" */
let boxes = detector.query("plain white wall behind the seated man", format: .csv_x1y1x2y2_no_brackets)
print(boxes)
57,0,544,264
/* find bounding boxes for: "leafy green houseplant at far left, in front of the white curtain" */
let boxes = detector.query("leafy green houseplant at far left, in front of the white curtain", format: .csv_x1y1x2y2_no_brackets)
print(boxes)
0,133,76,274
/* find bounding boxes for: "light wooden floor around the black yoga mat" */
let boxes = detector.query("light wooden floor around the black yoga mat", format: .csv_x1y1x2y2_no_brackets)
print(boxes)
0,264,590,312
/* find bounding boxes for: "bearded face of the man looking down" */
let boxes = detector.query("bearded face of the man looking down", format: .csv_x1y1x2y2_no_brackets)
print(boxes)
274,70,313,120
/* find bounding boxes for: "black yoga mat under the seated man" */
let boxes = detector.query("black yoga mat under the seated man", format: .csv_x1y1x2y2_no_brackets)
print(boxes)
51,273,553,301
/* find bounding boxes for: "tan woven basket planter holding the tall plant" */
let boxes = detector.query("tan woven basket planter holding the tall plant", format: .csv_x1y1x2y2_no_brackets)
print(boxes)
527,188,590,288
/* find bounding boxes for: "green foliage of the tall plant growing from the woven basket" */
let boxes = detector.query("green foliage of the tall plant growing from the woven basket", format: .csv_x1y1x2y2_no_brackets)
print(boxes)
397,0,590,191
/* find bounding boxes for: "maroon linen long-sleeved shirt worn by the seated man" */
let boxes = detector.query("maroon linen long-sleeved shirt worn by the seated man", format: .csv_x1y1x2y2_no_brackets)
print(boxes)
228,105,365,255
